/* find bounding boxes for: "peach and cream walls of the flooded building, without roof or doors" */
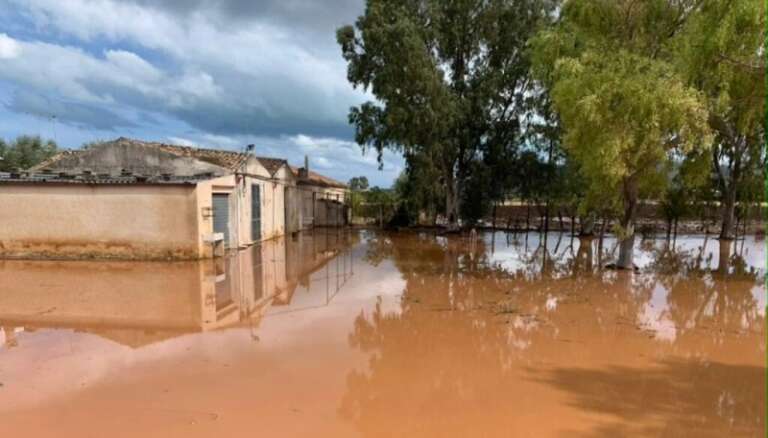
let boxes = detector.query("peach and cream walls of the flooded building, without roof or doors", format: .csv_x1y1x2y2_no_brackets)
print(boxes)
0,157,346,260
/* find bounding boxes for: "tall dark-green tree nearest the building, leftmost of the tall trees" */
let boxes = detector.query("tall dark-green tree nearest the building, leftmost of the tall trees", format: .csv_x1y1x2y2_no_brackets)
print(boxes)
337,0,554,228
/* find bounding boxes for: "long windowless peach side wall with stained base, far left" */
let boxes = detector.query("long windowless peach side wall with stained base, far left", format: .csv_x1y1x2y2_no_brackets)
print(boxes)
0,184,200,259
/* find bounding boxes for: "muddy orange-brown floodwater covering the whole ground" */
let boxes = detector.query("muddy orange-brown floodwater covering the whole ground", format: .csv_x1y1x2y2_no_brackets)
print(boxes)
0,230,766,438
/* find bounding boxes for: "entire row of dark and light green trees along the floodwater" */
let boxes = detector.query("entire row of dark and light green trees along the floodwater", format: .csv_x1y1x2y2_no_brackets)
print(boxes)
337,0,766,267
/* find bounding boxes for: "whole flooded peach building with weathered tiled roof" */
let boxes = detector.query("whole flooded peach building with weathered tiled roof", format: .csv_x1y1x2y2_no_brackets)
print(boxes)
0,138,347,259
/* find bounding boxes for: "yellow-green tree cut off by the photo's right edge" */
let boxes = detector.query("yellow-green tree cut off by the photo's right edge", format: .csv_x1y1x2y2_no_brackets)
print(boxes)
675,0,765,239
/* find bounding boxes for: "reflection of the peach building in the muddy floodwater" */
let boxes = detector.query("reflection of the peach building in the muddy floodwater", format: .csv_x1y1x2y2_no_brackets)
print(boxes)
0,230,356,348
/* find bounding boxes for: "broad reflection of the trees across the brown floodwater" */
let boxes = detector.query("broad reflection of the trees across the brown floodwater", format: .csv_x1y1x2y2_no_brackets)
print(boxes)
341,231,765,437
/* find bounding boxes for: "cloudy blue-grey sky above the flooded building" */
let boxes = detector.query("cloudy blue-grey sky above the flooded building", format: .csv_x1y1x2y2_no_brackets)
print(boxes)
0,0,402,186
